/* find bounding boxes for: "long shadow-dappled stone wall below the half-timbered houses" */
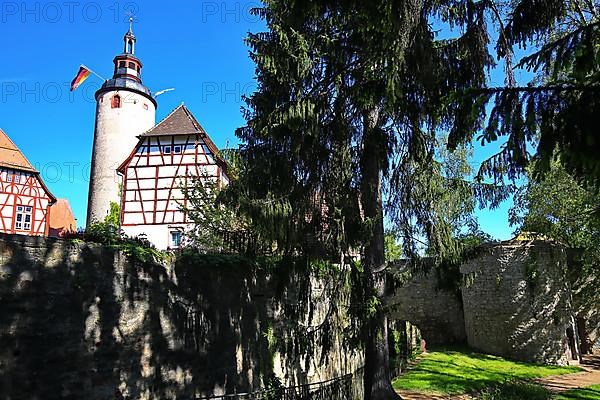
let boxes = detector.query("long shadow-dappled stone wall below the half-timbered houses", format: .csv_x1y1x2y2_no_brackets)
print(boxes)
0,236,362,400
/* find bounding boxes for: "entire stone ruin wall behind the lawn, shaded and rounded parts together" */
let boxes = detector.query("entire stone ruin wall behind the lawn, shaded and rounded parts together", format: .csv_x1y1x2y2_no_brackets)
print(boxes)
388,241,584,364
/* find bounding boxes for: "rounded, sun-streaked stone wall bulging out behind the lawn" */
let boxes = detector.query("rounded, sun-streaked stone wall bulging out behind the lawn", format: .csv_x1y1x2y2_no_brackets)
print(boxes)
461,241,577,364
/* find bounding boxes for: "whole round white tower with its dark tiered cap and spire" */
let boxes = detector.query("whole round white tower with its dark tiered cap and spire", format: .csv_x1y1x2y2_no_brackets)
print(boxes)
87,19,157,226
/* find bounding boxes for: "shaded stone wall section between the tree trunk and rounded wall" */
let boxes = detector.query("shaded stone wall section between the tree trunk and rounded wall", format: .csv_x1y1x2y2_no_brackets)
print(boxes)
387,266,466,345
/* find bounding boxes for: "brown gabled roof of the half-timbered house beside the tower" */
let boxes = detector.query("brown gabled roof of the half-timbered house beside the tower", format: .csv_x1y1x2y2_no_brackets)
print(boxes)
117,103,227,173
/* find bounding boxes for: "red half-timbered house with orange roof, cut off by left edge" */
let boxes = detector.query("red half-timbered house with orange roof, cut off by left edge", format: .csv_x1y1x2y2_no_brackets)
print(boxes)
0,129,56,236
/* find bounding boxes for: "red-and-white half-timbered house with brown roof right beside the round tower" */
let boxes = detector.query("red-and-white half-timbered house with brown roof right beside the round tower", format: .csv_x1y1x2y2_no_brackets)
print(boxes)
118,104,229,249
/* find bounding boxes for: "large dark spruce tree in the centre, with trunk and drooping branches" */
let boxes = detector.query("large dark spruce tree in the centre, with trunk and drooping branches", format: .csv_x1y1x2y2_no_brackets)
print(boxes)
232,0,502,400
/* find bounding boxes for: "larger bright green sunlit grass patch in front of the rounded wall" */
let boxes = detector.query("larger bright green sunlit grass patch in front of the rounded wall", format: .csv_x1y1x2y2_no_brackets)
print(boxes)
393,350,581,395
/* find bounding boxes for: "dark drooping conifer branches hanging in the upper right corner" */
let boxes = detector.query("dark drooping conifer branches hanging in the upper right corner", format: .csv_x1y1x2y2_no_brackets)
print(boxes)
449,0,600,184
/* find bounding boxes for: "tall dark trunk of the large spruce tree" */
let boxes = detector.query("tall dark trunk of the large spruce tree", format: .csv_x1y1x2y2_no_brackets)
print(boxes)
361,109,400,400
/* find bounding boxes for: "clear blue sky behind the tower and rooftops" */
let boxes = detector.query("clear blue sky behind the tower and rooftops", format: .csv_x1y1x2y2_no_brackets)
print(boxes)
0,0,528,239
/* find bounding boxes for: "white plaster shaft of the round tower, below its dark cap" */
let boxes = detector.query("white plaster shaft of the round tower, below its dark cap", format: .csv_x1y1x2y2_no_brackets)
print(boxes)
87,90,156,225
